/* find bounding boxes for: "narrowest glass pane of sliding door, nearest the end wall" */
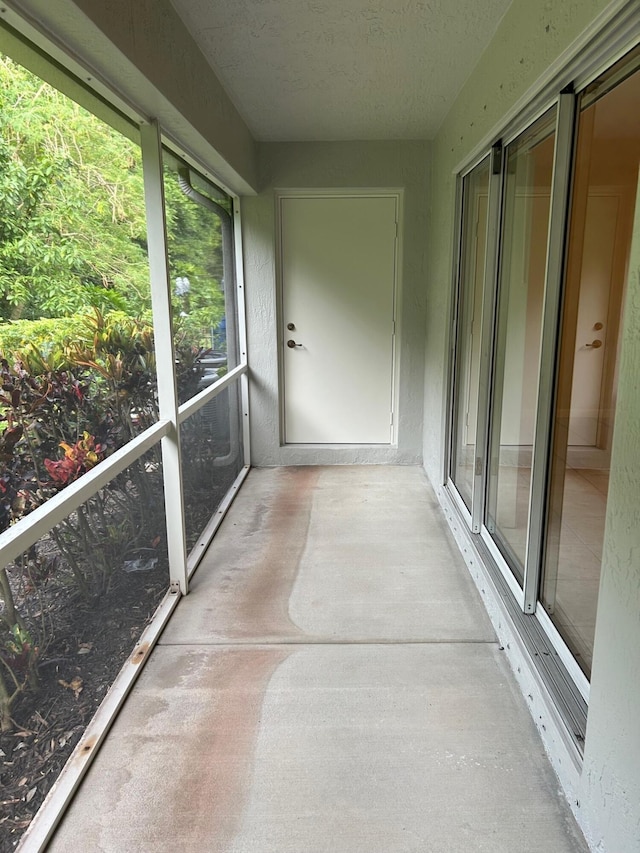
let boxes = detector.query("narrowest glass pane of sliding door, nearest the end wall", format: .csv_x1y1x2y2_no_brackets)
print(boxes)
451,158,489,510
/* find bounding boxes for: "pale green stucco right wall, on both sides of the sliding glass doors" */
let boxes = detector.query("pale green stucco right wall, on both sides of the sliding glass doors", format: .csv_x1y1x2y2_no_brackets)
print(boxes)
423,0,640,853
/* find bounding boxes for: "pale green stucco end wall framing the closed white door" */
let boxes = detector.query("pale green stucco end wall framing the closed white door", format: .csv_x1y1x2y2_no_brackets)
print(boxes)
242,142,429,465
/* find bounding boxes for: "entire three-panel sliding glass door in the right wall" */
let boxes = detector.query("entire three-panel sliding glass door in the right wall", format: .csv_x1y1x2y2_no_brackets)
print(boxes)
448,43,640,688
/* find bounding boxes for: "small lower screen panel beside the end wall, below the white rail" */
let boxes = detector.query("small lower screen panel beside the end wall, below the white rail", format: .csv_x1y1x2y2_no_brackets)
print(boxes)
180,381,244,551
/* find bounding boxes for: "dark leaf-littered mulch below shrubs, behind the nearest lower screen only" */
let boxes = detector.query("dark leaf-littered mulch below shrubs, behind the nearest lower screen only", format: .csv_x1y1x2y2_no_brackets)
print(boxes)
0,561,168,853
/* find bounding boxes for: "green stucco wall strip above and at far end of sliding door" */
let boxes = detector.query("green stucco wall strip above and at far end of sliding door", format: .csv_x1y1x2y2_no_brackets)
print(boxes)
423,0,620,483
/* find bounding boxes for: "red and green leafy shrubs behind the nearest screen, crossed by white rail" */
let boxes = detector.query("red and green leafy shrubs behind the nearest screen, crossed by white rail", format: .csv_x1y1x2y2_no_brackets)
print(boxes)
0,311,168,728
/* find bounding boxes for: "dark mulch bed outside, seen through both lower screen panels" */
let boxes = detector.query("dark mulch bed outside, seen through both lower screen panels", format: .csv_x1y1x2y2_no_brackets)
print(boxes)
0,436,239,853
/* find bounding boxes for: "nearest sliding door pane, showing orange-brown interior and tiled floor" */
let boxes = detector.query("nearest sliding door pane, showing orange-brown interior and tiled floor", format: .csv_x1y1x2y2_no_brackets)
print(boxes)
541,62,640,676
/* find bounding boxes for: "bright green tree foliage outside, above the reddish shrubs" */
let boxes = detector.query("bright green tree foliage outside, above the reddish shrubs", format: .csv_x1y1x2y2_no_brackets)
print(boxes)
0,57,224,329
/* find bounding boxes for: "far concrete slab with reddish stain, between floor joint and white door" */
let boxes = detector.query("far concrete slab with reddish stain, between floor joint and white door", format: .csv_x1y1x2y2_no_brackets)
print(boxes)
162,466,494,644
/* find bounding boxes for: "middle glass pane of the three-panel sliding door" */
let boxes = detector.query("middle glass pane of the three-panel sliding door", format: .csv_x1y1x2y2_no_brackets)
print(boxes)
486,108,556,585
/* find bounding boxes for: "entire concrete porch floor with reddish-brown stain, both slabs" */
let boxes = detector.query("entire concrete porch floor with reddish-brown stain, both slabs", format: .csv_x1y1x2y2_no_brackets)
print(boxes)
49,466,587,853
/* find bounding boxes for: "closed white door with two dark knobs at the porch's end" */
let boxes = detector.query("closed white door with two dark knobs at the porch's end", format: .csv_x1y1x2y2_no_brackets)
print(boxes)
280,196,398,444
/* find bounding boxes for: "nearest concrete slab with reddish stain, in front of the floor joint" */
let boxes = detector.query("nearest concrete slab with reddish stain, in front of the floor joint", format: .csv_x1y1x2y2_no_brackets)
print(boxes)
50,643,586,853
